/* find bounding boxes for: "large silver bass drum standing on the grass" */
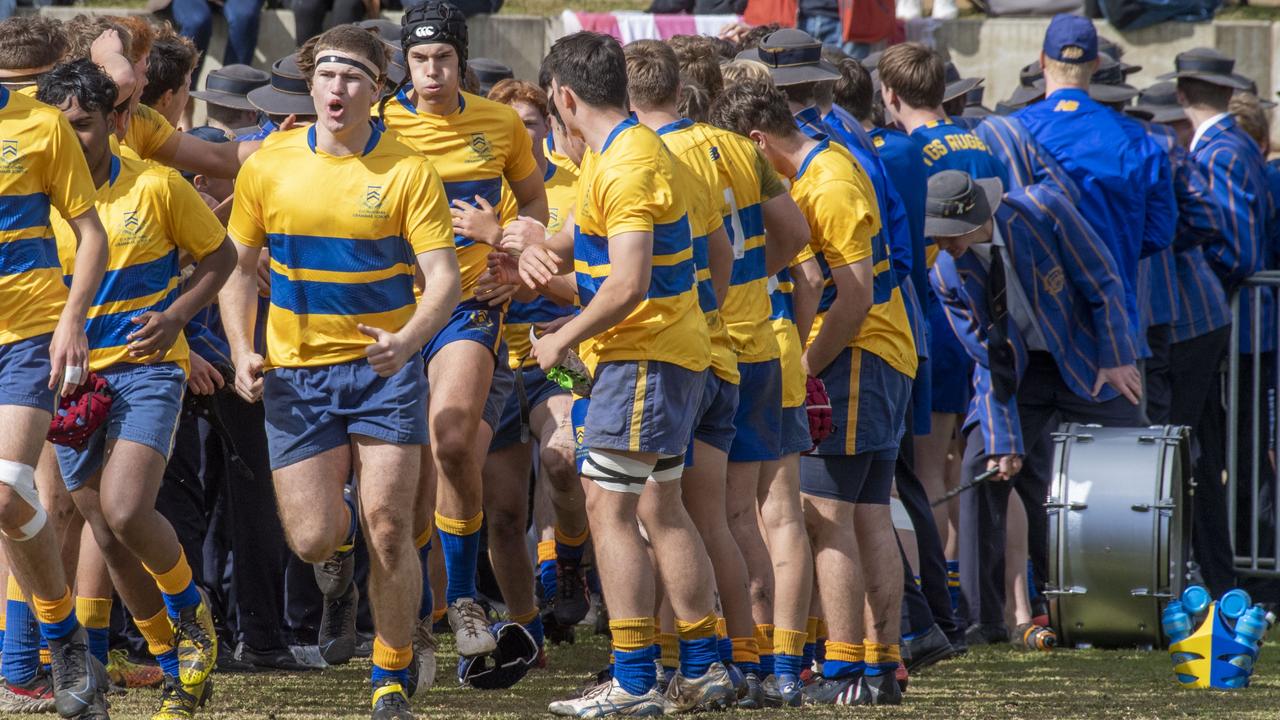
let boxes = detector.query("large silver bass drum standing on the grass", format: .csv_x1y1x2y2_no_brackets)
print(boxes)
1044,423,1192,647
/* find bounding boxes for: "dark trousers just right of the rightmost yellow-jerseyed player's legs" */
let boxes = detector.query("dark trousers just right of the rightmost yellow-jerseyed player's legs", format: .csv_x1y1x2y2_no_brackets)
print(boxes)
893,409,964,639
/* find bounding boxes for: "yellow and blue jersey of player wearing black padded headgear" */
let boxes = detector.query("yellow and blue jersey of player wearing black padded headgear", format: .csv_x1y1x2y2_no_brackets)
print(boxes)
383,88,538,301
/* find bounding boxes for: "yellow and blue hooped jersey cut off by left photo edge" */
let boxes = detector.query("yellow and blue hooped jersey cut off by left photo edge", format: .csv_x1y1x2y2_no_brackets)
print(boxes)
0,87,95,345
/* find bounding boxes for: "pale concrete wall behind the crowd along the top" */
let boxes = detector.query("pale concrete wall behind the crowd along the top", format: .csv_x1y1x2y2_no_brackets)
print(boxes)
27,6,1280,117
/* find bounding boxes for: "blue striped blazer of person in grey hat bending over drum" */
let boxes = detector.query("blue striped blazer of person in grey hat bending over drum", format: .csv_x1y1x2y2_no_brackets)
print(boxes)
931,184,1137,455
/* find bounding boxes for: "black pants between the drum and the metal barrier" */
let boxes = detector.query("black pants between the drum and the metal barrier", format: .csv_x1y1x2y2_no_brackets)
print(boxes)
1169,327,1235,597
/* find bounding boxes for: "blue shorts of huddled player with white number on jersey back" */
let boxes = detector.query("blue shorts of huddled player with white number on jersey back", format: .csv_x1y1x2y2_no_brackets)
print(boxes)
728,360,778,462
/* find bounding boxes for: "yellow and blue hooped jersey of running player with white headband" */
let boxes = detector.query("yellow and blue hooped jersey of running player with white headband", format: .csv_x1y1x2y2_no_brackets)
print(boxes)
228,127,453,368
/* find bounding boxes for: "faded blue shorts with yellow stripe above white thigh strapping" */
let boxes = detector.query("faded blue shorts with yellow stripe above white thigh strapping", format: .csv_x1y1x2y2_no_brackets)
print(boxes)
575,360,710,456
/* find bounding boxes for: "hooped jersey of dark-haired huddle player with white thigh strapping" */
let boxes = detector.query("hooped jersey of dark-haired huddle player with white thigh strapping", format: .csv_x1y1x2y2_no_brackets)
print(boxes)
573,117,710,372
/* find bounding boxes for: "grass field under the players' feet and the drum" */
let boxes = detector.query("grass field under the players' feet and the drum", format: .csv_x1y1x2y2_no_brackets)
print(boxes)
12,627,1280,720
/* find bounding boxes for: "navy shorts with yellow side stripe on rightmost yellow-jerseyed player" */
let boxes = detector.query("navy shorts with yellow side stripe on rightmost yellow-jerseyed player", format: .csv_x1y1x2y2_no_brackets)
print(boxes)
814,347,911,455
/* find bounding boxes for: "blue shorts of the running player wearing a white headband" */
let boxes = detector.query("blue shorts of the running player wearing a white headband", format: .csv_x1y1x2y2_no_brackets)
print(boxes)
262,355,428,470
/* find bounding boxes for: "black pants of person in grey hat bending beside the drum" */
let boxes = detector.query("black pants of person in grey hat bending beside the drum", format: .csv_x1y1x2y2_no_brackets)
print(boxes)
960,352,1139,625
